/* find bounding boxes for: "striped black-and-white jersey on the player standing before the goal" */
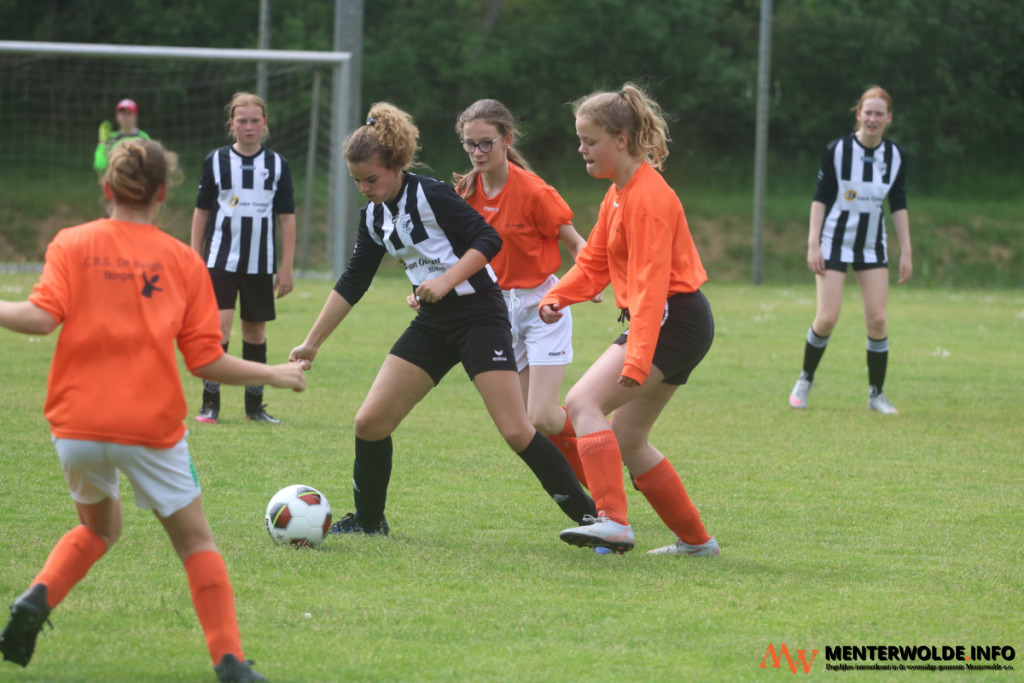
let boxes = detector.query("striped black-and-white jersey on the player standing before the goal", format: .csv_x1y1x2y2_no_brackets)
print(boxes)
196,145,295,274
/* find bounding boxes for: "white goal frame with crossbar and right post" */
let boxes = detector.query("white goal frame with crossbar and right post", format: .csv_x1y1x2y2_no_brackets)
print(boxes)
0,40,354,276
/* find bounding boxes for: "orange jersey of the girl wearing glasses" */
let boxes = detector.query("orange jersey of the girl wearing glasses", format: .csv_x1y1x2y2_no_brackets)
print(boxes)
466,163,572,290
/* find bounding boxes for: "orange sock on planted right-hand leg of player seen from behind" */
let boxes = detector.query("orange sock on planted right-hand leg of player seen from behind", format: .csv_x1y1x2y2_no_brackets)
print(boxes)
183,550,245,666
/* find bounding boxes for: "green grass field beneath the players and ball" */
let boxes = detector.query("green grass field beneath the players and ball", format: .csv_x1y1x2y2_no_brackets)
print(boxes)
0,269,1024,682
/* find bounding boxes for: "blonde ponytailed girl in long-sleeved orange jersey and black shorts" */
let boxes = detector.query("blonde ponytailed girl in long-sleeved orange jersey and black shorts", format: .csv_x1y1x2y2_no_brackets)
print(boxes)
540,83,719,556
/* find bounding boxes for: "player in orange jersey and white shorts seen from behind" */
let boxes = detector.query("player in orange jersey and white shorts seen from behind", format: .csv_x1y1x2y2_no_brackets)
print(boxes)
0,139,305,681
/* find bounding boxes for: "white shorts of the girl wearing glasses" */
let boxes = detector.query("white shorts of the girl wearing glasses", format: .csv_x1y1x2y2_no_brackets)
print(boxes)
502,274,572,372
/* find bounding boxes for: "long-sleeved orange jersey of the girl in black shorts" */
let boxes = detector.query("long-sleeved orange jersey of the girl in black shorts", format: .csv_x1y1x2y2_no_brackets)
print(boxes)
540,163,708,383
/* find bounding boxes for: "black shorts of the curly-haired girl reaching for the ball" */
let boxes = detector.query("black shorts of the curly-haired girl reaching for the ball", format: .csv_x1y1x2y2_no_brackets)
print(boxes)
391,289,516,385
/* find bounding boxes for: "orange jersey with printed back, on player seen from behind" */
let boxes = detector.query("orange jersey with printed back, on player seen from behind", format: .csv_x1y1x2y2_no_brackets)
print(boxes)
29,219,224,449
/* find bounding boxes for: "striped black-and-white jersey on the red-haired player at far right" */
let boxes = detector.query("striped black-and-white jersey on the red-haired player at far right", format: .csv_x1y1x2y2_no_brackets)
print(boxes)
814,133,906,263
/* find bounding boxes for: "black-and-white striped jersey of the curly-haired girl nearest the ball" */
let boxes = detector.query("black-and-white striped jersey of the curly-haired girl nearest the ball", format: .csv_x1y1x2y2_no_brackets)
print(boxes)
335,172,502,304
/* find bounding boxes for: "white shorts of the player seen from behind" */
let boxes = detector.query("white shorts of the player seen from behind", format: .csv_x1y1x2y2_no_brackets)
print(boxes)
53,436,200,517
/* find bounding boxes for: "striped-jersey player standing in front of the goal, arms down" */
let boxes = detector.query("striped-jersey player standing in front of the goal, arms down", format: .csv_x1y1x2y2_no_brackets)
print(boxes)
191,92,295,424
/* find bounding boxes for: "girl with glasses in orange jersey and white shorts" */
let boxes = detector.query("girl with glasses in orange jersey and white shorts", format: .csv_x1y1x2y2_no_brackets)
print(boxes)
453,99,601,486
